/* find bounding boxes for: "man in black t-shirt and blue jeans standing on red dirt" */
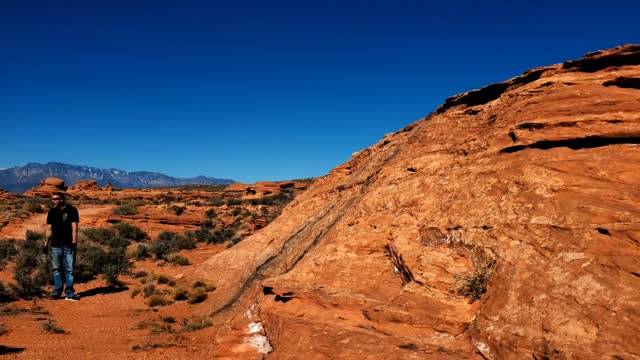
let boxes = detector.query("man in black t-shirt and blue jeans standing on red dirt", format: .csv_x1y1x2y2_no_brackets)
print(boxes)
47,193,80,301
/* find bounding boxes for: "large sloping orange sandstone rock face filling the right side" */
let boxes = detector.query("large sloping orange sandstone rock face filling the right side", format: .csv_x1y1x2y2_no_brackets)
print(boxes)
199,46,640,359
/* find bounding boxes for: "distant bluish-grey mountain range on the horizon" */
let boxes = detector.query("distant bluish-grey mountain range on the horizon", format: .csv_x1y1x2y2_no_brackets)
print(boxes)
0,162,235,193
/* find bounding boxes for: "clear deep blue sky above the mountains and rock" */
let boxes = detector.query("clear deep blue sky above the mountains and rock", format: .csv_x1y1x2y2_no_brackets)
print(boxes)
0,0,640,183
